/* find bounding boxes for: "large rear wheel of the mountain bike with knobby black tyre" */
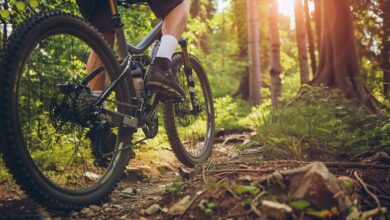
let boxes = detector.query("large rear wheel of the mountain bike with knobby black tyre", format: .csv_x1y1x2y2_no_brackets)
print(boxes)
0,13,131,210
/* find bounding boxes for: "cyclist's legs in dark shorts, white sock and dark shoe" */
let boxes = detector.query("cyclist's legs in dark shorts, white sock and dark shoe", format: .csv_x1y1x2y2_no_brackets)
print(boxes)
77,0,189,98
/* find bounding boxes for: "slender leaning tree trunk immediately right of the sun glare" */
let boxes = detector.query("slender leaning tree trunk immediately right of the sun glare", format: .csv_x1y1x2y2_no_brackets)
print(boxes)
295,0,309,85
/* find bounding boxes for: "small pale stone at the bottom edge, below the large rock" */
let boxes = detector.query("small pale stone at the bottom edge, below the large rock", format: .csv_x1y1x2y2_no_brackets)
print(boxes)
259,200,292,220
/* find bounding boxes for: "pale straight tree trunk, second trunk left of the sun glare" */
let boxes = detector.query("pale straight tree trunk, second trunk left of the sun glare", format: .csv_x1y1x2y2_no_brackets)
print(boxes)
247,0,261,106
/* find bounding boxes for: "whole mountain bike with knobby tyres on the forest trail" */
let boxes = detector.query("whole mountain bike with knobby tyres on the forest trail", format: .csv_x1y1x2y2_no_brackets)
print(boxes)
0,0,215,210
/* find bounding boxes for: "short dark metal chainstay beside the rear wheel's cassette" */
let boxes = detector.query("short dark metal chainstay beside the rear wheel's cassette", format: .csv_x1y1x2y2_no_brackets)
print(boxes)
98,109,139,128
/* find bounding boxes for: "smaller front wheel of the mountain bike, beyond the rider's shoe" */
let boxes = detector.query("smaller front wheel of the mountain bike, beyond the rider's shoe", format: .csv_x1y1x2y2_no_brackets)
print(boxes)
164,53,215,167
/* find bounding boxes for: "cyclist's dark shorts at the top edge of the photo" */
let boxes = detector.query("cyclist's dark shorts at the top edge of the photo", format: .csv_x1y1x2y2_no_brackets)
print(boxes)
76,0,183,32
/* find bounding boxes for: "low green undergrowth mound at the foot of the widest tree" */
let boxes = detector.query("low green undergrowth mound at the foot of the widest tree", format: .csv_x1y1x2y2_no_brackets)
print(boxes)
251,86,390,159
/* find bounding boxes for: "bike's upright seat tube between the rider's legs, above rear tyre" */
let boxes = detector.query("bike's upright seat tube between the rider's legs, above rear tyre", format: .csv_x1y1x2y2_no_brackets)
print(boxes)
107,0,129,60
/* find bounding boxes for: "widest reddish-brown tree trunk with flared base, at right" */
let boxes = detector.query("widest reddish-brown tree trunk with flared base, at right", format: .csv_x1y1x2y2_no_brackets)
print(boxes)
312,0,381,114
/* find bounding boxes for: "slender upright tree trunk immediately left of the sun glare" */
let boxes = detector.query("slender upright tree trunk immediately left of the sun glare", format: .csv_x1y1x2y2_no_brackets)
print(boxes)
269,0,282,108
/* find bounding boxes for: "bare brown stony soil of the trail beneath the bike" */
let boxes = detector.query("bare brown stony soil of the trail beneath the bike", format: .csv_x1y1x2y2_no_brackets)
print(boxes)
0,131,390,219
